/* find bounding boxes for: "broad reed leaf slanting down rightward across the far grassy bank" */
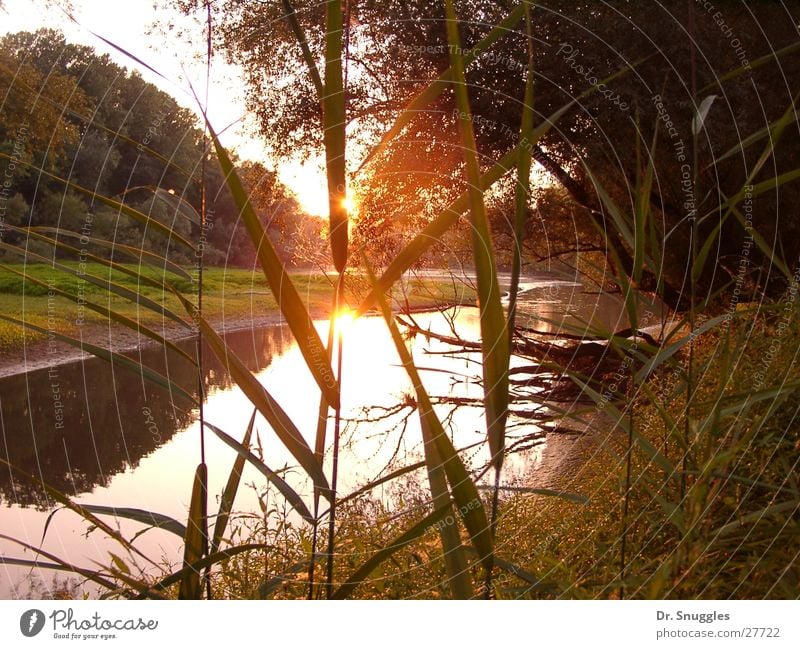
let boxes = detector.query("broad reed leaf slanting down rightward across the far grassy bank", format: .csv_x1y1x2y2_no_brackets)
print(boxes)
206,118,339,408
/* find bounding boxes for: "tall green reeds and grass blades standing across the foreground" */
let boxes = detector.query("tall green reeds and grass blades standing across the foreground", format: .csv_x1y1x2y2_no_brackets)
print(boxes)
0,0,800,599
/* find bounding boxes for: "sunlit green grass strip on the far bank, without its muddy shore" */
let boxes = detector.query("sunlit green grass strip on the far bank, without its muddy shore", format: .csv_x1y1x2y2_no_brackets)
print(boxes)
0,262,475,352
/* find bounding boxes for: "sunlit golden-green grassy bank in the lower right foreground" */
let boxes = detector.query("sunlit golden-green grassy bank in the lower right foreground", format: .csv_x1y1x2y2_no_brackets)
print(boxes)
472,305,800,599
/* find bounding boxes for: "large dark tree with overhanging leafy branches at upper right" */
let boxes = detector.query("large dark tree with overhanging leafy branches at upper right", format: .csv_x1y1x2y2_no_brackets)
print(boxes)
173,0,800,307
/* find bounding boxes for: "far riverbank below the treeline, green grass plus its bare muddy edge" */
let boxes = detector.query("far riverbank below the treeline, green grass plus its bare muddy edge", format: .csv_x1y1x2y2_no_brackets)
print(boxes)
0,264,475,377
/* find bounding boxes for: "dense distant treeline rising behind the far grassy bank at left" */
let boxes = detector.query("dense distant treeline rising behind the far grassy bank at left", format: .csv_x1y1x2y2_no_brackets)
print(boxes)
0,30,324,266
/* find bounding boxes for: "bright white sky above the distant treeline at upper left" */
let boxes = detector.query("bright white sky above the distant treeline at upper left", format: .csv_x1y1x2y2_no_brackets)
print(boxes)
0,0,328,216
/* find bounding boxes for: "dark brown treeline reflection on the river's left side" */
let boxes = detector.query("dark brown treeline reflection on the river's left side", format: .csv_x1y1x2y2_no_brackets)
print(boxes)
0,326,291,508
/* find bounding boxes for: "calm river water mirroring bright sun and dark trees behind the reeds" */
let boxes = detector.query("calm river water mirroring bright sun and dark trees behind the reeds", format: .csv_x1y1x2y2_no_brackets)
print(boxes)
0,270,626,597
